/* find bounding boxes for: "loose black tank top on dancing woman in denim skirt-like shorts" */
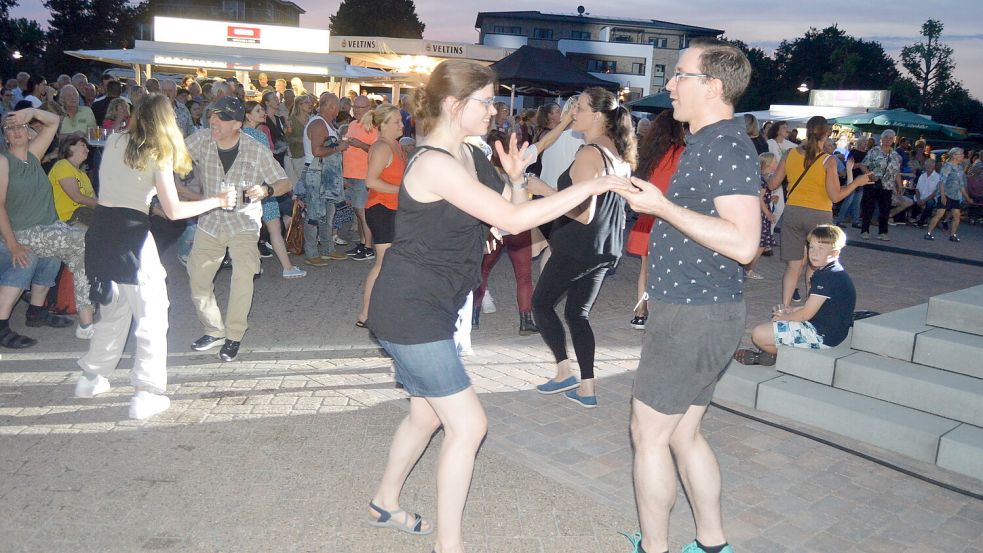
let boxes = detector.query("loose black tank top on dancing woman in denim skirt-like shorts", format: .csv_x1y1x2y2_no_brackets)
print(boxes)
366,145,505,344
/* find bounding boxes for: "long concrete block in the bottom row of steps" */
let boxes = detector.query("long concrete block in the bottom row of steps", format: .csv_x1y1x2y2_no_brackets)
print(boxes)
757,375,959,463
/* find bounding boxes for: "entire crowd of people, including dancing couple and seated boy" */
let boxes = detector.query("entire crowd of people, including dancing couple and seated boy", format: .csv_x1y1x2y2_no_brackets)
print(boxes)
0,39,983,553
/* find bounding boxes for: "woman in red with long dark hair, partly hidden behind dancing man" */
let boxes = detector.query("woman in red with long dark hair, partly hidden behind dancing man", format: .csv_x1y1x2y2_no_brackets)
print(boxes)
625,108,686,330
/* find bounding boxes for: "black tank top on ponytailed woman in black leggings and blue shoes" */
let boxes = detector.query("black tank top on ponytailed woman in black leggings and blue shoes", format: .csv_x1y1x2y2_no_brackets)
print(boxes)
550,144,631,265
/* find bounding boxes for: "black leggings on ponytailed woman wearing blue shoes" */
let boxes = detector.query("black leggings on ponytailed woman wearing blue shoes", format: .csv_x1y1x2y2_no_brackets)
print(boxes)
532,253,611,380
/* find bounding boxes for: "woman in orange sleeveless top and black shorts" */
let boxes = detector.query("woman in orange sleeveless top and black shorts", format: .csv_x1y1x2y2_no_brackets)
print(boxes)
355,104,406,328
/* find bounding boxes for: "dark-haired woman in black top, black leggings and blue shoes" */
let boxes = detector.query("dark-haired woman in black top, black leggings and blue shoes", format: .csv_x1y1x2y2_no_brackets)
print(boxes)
532,88,636,408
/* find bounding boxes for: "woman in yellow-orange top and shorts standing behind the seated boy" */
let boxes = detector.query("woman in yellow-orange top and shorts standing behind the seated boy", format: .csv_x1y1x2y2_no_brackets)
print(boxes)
768,115,870,306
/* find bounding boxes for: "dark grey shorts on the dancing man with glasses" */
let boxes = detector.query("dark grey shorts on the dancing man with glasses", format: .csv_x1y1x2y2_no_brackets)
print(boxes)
632,301,747,415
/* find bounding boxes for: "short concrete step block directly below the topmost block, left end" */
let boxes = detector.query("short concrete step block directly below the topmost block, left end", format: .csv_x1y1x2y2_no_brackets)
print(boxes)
852,303,931,361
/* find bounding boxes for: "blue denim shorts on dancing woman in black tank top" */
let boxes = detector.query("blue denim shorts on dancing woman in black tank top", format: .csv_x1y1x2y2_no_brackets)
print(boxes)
379,339,471,397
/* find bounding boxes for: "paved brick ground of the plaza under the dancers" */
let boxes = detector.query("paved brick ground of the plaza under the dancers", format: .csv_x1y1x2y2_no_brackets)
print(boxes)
0,221,983,553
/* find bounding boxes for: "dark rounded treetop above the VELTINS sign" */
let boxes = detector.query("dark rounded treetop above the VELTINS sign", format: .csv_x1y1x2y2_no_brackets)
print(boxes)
328,0,426,38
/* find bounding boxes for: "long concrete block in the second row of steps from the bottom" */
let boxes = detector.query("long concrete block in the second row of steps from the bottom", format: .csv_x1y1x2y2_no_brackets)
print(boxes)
833,352,983,426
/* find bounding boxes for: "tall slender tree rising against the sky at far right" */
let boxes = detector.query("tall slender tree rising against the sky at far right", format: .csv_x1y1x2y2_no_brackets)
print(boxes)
901,19,956,113
